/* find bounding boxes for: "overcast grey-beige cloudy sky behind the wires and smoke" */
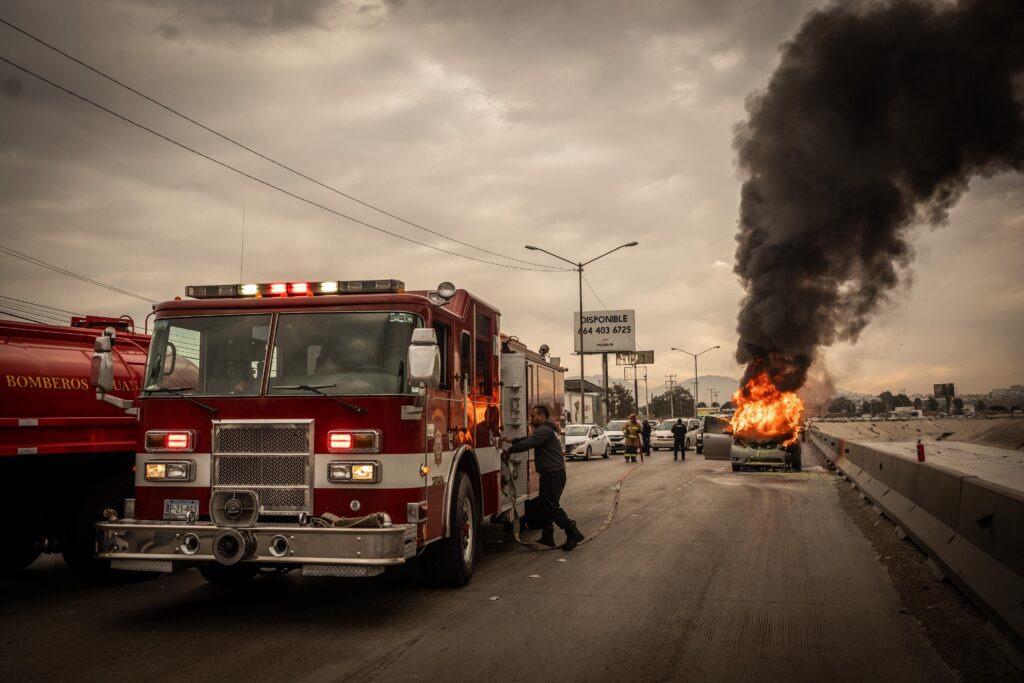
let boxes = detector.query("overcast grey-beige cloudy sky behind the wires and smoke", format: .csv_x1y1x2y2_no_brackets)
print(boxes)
0,0,1024,399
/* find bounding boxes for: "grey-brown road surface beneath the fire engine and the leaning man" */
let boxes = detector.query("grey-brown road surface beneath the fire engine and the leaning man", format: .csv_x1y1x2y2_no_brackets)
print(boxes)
0,452,955,683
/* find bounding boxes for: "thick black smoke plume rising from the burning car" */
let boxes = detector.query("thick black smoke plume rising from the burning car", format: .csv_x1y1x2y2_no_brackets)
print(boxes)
734,0,1024,390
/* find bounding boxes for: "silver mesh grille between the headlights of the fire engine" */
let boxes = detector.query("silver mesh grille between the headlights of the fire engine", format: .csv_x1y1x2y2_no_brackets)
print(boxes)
213,422,313,515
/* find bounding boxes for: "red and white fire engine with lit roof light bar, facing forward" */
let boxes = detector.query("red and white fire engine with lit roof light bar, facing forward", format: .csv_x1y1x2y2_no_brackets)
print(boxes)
93,280,563,586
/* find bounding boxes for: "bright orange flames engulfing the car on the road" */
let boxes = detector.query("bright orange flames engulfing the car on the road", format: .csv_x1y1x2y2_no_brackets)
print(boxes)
732,373,804,445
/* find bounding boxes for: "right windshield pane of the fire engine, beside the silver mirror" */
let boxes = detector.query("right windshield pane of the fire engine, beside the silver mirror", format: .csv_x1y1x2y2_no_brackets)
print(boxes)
267,311,422,396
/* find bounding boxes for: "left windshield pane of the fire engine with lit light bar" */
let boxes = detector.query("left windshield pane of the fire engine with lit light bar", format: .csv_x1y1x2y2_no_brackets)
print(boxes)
144,313,270,396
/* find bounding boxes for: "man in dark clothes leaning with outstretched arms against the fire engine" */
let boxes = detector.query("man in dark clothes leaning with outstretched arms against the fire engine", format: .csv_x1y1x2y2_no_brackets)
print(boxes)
502,405,585,551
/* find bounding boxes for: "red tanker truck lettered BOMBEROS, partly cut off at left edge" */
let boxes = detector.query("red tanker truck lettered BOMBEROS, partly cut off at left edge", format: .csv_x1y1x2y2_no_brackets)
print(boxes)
0,316,150,574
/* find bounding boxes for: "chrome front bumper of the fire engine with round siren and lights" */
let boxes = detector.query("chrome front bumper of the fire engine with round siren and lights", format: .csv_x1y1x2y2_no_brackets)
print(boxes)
96,519,417,577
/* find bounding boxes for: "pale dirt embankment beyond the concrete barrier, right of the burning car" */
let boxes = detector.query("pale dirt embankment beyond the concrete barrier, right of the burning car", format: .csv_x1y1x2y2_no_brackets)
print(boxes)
806,417,1024,451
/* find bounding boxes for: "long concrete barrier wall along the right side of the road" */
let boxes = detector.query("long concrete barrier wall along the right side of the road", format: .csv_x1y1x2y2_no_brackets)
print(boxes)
807,428,1024,648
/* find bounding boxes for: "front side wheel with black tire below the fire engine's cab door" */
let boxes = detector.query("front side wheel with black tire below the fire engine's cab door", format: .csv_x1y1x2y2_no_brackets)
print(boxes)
423,472,480,588
